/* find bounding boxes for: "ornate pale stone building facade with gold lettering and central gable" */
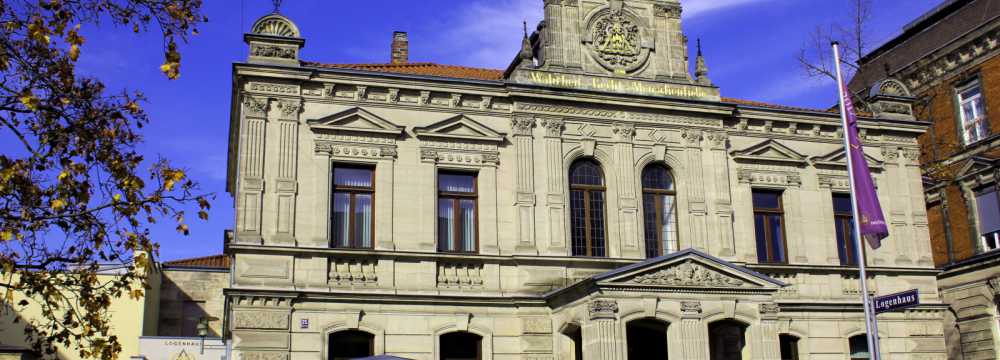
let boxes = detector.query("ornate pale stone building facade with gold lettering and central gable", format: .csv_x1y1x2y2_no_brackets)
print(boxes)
225,0,946,360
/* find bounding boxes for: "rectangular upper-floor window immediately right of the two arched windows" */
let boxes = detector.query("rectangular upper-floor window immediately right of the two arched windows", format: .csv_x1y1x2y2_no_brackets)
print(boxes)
753,190,788,264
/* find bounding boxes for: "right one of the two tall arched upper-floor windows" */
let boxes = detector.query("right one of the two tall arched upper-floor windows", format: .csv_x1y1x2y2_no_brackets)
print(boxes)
642,164,677,258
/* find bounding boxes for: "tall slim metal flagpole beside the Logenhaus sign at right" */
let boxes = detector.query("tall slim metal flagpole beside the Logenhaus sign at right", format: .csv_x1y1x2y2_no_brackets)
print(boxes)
832,42,882,360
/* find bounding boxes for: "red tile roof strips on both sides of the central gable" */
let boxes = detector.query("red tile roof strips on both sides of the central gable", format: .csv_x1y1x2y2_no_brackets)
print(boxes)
302,61,839,113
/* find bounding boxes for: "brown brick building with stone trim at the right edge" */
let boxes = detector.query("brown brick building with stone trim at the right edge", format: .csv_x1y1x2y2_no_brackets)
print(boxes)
851,0,1000,359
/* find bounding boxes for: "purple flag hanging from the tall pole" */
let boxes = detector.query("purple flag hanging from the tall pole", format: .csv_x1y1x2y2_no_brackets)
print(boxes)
840,83,889,249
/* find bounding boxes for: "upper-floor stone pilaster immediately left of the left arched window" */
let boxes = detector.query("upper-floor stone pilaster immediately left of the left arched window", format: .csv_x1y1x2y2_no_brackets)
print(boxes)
541,118,567,253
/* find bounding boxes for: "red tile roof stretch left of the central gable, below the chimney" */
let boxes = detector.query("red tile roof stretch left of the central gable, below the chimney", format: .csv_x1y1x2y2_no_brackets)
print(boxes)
302,61,503,81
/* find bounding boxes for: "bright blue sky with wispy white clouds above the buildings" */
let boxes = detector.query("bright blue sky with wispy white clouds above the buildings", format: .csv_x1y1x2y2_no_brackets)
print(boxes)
66,0,941,260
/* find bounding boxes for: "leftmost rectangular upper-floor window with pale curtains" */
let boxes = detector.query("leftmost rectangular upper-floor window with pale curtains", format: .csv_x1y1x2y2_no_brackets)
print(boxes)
330,166,375,249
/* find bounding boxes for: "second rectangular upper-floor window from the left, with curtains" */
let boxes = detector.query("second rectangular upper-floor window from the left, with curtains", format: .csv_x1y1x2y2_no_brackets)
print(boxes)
438,172,479,252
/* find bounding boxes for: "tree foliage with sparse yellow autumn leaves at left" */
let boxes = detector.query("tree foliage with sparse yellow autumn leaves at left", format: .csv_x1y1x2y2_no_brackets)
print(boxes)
0,0,209,359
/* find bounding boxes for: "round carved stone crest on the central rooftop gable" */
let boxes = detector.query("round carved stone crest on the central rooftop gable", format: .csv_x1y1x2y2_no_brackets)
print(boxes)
584,0,649,74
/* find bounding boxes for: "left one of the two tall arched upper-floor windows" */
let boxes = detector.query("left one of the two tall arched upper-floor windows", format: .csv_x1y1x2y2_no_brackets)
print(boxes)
569,159,607,256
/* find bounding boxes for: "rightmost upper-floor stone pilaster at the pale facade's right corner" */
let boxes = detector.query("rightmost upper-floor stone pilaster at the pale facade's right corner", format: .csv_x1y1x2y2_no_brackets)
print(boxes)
903,148,934,266
